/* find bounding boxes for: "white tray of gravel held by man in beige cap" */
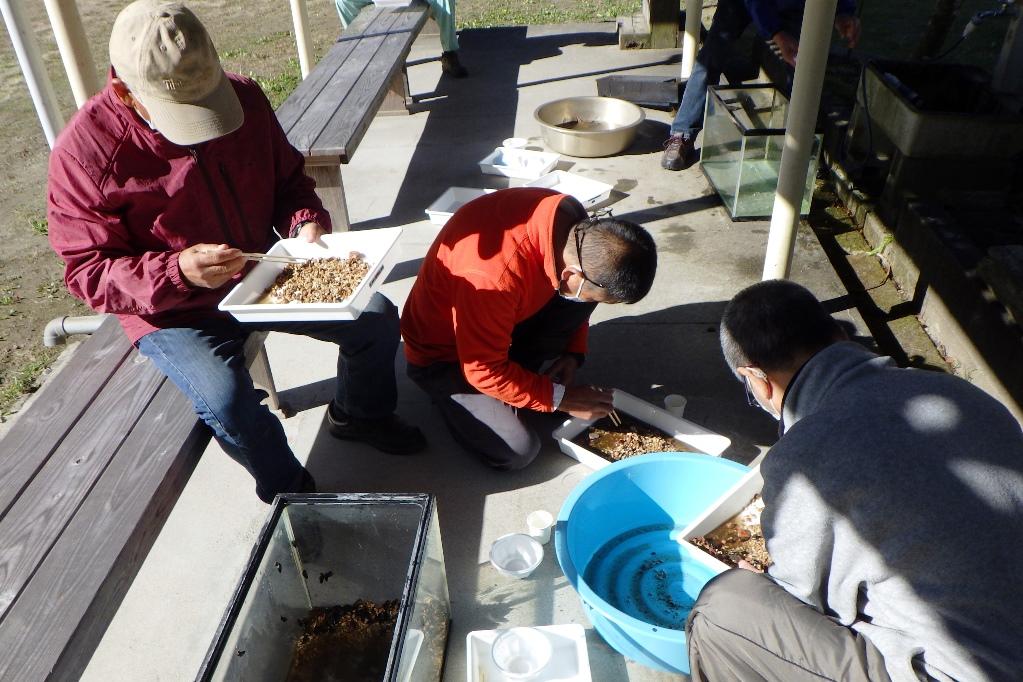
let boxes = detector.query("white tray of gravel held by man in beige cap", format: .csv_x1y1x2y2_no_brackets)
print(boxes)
219,227,402,322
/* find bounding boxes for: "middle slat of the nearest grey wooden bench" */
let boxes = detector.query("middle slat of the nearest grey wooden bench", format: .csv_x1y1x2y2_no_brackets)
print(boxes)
0,349,165,625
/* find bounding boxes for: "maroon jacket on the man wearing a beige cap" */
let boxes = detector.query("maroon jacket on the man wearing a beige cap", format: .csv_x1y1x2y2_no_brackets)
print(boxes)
47,74,330,344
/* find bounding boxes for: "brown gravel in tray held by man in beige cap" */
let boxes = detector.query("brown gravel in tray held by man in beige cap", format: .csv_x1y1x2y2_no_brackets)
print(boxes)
263,253,369,304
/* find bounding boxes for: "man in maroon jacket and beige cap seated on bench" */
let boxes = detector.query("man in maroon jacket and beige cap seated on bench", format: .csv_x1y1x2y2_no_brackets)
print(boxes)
48,0,426,502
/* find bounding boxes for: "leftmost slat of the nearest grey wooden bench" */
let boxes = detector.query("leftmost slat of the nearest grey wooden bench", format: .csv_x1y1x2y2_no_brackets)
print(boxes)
0,317,132,517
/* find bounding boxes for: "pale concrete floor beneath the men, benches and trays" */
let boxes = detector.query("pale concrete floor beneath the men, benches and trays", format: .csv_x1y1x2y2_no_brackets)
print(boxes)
84,22,864,682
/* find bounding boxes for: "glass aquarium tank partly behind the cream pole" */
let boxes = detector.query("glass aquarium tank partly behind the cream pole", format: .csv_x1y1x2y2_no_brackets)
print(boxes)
700,85,822,220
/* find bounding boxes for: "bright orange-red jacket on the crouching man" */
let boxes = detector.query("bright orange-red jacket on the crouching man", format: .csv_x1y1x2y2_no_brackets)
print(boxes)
401,188,589,412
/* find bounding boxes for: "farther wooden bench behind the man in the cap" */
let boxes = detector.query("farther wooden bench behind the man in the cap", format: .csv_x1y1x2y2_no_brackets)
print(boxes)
277,0,428,231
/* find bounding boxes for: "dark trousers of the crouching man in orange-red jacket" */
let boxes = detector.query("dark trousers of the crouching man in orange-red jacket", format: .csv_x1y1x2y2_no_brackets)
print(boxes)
407,293,596,469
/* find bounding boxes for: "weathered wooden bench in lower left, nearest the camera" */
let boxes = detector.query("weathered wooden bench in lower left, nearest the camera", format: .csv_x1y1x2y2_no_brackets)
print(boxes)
0,316,276,681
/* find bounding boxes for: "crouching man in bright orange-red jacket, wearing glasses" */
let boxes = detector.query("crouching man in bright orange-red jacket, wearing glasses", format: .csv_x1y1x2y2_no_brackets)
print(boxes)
401,187,657,469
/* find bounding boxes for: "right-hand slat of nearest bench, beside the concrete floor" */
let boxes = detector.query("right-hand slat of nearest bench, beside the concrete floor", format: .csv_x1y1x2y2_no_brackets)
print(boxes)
0,381,210,680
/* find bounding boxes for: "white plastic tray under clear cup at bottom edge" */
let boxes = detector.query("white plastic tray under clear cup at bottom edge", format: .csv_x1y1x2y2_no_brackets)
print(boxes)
465,623,591,682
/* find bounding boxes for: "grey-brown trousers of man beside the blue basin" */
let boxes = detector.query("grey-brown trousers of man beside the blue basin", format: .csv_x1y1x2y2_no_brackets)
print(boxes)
685,569,891,682
